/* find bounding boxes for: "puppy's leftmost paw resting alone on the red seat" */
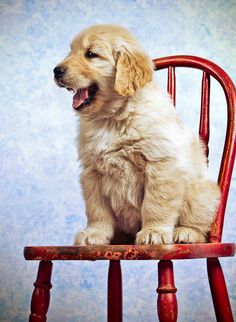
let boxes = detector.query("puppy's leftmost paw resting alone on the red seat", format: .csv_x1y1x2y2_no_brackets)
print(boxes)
74,229,110,246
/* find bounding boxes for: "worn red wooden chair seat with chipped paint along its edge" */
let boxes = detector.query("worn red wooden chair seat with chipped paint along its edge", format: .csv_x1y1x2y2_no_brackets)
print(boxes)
24,243,235,261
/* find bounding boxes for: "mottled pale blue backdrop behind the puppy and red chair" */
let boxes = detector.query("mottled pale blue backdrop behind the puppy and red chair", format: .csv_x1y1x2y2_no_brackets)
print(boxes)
0,0,236,322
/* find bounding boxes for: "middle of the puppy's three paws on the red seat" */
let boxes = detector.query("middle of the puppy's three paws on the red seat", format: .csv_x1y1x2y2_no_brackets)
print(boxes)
135,228,173,245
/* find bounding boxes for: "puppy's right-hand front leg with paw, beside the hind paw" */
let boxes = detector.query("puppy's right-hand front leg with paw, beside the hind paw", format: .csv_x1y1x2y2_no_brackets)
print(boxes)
136,160,184,244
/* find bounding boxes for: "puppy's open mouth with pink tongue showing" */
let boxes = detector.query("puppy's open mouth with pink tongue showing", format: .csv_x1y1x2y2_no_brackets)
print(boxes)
72,84,98,111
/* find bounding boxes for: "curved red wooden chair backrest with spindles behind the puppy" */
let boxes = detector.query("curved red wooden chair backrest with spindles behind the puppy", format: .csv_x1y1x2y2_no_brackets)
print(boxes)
153,55,236,243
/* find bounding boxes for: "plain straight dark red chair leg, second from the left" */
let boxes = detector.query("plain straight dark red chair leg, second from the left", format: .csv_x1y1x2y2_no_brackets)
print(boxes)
107,260,122,322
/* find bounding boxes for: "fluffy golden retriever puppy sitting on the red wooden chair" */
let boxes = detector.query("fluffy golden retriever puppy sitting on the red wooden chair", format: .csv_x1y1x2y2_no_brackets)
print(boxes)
54,25,219,245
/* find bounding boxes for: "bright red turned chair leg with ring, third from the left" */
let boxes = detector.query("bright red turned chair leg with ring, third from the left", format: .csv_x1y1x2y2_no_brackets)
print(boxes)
157,260,178,322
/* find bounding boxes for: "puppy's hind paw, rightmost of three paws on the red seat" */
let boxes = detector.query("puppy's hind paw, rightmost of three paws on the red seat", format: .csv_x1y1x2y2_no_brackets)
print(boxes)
174,227,206,244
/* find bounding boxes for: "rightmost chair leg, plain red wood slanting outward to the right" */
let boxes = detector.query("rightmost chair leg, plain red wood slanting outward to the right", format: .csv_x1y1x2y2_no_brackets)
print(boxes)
207,258,234,322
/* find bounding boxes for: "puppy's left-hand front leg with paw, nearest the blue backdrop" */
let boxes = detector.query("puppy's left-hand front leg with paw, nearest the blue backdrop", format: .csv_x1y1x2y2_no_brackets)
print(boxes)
75,169,115,245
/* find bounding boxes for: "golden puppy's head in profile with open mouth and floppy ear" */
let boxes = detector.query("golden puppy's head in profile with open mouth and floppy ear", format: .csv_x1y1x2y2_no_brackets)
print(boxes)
54,25,153,114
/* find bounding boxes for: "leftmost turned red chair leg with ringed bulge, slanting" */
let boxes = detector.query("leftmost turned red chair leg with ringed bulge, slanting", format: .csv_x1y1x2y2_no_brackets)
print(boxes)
29,261,52,322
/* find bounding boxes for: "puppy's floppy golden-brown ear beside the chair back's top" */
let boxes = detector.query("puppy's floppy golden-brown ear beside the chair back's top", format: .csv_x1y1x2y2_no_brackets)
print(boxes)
115,50,153,96
